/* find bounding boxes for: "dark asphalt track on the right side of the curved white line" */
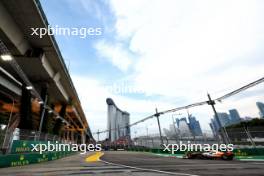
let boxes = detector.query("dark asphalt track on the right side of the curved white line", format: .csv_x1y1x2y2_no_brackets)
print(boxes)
101,151,264,176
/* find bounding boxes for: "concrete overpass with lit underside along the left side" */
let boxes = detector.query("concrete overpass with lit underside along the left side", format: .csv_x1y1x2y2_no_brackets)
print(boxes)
0,0,93,150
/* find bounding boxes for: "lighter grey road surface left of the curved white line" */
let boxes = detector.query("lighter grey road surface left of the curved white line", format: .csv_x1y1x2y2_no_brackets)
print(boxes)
0,153,171,176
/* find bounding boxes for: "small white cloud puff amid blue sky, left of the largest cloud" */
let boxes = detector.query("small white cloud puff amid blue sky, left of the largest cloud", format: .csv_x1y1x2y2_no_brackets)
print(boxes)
95,41,132,72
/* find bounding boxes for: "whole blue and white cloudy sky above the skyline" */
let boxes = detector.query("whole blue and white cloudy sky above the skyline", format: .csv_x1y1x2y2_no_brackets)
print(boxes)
41,0,264,137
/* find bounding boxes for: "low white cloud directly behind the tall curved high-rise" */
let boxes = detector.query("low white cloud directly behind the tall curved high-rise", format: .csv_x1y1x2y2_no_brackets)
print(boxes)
72,75,177,132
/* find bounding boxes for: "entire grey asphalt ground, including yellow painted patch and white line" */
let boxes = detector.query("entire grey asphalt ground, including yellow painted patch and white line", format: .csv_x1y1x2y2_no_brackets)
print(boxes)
0,151,264,176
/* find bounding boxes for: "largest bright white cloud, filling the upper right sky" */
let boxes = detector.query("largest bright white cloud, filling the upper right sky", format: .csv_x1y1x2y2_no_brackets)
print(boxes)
108,0,264,100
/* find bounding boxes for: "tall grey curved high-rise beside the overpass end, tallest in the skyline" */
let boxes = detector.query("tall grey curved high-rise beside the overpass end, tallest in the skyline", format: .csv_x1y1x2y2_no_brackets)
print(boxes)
106,98,130,141
